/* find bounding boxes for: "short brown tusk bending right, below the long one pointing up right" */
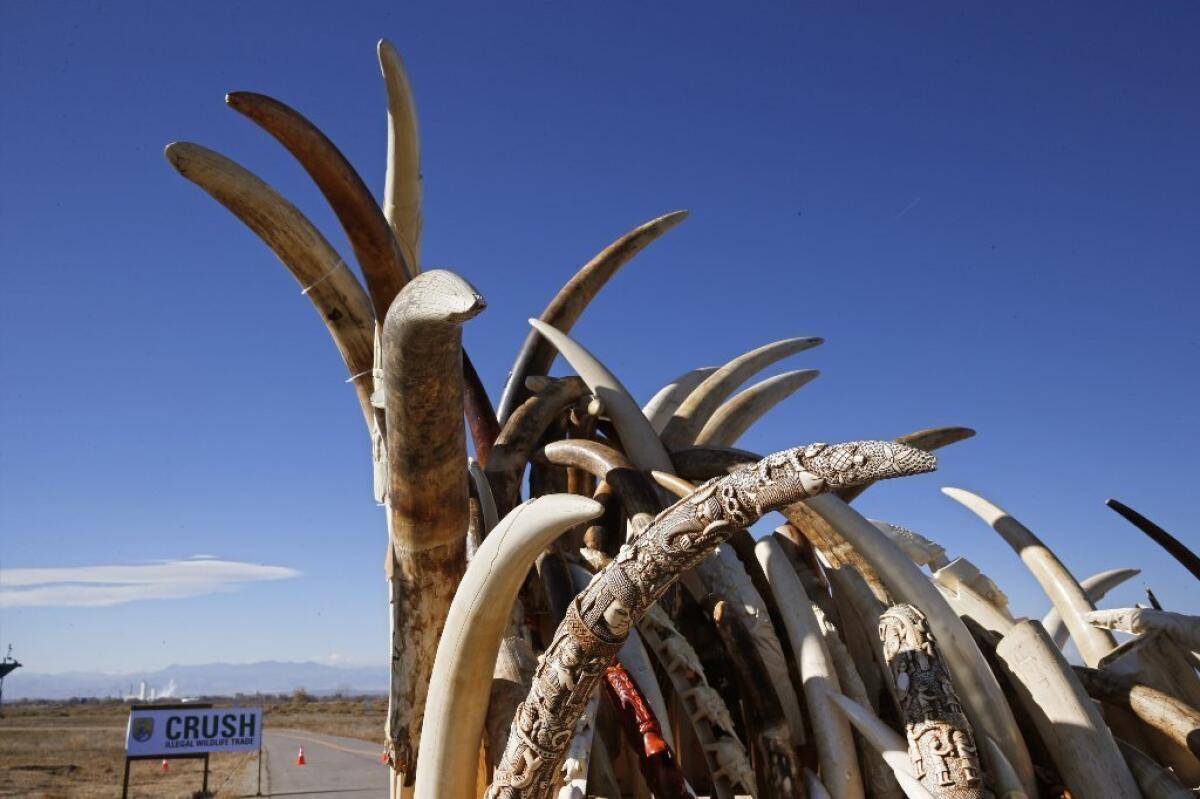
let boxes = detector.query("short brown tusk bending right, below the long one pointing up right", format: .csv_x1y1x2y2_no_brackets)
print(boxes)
484,377,587,515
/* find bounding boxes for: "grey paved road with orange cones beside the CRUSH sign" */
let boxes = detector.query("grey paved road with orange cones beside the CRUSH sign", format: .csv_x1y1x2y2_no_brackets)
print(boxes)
249,729,388,799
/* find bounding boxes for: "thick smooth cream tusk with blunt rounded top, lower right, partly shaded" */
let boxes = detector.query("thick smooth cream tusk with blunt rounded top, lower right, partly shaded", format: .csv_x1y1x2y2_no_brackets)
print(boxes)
996,619,1140,799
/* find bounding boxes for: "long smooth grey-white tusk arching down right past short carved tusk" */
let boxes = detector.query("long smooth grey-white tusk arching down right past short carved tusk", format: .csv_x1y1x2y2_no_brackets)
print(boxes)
805,495,1037,795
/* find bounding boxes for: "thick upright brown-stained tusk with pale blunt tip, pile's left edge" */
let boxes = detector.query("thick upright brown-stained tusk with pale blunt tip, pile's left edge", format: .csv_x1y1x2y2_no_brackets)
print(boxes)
382,270,485,781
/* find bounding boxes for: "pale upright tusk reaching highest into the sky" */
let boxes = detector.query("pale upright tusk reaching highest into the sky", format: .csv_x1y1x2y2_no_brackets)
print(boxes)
377,38,421,275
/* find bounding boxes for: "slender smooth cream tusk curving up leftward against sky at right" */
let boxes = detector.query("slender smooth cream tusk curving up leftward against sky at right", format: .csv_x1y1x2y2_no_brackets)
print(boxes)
942,488,1116,666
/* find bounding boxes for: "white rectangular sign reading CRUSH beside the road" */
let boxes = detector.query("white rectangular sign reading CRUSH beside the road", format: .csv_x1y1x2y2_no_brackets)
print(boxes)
125,708,263,757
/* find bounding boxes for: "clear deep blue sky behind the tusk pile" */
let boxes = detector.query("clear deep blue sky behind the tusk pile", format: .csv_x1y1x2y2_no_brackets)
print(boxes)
0,1,1200,672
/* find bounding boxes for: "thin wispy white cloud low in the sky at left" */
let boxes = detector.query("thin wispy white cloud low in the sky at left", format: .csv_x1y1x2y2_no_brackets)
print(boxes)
0,555,300,607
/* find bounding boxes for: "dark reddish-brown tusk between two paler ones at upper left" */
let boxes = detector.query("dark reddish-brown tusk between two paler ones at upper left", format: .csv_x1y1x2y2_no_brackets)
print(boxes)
226,91,412,319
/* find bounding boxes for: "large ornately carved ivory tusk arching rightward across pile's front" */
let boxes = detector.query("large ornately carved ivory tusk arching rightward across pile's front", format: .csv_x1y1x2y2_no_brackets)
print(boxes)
488,439,936,799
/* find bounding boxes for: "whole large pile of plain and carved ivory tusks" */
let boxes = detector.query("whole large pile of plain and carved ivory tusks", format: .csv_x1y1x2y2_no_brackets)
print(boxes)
166,42,1200,799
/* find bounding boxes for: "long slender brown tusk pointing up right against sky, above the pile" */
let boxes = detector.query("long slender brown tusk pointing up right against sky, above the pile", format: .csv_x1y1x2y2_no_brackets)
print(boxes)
497,211,688,423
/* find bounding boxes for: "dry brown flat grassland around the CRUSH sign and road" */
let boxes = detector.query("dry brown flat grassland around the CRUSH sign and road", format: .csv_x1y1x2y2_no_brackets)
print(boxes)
0,691,388,799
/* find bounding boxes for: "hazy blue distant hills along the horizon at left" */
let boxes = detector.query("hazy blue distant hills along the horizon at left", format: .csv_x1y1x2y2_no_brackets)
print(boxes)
4,660,388,699
